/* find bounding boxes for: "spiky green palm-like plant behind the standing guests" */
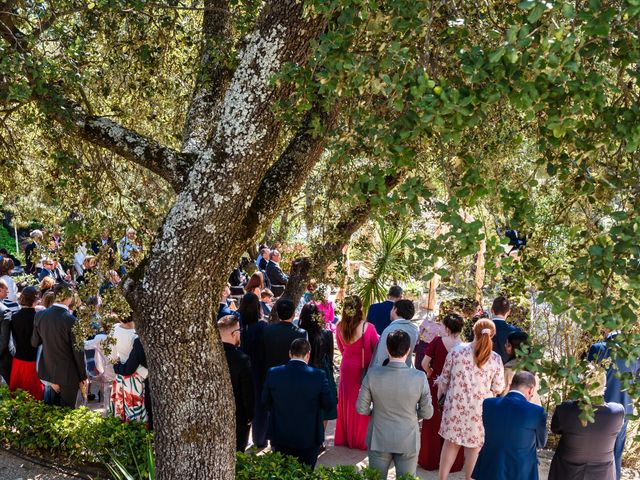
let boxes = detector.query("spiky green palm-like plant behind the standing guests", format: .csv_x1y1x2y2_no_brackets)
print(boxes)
354,221,409,312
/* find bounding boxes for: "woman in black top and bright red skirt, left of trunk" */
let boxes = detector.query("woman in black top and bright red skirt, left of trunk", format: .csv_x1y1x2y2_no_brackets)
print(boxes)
9,287,44,400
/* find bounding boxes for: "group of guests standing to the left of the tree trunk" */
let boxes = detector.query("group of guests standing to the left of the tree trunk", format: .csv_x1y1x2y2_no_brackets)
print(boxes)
0,228,152,426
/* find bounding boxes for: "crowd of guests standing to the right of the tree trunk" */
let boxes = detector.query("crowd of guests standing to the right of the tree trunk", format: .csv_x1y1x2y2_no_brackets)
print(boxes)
220,270,640,480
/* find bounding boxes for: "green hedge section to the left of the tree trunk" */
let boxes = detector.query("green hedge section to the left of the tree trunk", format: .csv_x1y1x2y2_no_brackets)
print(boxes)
0,386,153,467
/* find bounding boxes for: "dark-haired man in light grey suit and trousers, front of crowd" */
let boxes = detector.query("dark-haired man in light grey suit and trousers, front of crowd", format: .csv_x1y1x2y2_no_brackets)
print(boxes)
356,330,433,480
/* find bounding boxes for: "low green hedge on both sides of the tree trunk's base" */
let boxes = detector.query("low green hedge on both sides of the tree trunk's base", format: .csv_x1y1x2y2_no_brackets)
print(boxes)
0,386,414,480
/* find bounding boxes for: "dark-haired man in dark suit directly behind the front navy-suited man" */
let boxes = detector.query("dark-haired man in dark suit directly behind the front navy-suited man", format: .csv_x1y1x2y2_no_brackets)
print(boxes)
262,298,308,374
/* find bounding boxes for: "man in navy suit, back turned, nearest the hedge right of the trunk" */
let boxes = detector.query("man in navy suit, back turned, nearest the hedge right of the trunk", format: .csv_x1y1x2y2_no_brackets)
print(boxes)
262,339,336,468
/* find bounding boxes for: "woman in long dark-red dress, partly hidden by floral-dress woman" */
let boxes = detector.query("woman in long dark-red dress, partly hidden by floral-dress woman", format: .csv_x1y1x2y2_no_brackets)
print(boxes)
418,313,464,472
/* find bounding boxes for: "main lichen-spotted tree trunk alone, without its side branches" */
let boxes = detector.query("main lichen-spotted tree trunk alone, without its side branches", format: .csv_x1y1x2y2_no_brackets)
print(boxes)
129,4,324,480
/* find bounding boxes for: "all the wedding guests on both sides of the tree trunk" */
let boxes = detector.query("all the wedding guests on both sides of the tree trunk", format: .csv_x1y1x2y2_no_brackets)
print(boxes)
0,229,640,480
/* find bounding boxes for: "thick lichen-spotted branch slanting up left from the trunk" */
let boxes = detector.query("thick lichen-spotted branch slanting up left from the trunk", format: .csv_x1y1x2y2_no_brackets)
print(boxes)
42,97,193,192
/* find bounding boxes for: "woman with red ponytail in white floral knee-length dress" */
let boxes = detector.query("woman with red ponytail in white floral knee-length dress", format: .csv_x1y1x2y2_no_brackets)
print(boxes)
438,318,504,480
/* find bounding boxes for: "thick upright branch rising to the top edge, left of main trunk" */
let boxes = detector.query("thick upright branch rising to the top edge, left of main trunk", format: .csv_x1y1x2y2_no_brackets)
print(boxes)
182,0,233,152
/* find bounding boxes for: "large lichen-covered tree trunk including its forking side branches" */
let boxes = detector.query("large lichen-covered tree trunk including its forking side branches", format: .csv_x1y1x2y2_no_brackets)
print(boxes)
0,0,330,480
